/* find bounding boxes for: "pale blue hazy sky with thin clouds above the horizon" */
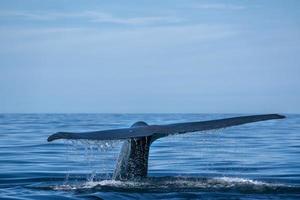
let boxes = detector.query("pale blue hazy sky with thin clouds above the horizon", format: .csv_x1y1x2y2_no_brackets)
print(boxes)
0,0,300,113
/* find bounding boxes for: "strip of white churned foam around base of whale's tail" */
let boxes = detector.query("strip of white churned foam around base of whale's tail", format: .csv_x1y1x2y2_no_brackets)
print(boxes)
53,177,283,191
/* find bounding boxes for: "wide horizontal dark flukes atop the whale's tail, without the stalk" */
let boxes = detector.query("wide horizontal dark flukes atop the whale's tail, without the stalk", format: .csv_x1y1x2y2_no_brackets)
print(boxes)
48,114,285,142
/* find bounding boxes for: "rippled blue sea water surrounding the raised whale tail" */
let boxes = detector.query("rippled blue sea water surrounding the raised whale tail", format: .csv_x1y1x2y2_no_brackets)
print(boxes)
0,114,300,199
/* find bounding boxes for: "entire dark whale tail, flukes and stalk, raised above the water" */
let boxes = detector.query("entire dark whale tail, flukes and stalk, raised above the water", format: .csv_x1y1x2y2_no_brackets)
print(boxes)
48,114,285,180
